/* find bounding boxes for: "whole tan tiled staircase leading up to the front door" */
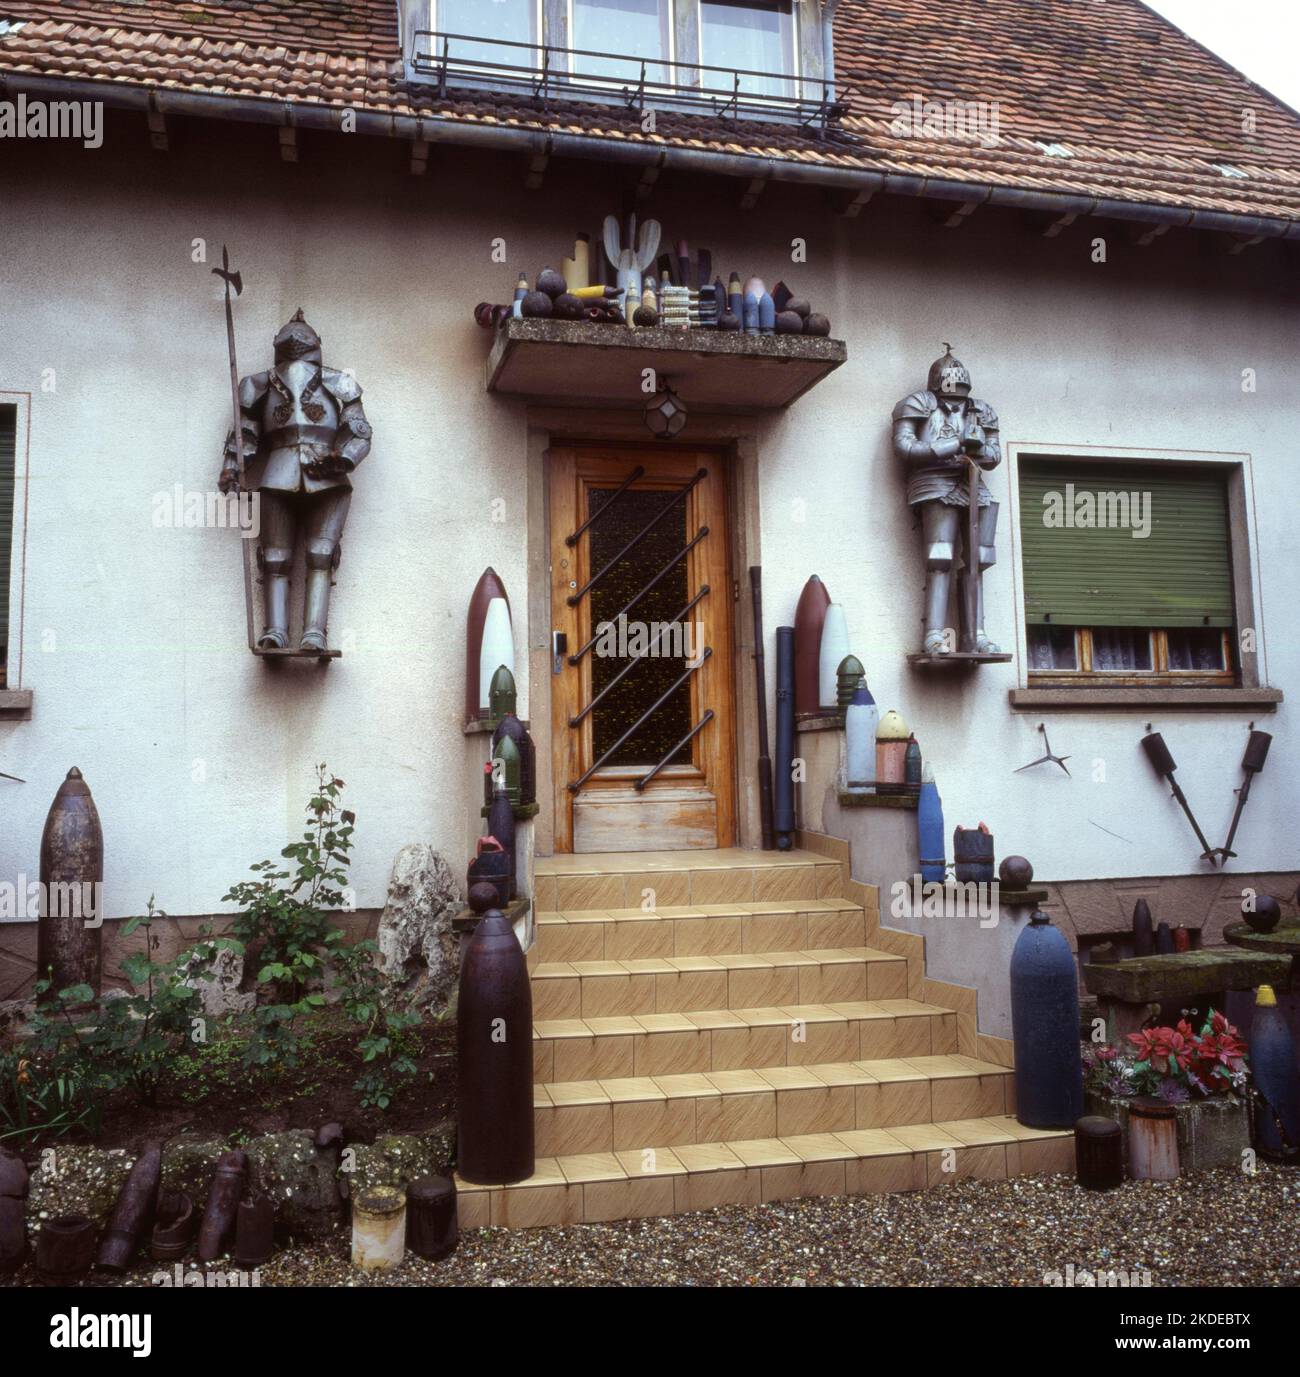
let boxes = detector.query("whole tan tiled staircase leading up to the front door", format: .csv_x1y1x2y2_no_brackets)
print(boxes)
459,834,1074,1228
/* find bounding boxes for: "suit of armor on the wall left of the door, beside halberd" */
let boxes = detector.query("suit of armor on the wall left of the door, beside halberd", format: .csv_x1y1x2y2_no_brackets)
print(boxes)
219,311,370,654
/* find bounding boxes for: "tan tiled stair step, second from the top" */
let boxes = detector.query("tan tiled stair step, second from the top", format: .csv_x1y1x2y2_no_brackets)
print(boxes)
537,898,876,964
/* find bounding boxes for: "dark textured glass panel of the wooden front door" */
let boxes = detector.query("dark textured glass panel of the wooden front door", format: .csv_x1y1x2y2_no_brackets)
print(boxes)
587,487,700,766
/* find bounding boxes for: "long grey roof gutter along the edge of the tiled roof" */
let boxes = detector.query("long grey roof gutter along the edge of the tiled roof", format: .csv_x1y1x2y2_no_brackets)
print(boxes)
10,72,1300,240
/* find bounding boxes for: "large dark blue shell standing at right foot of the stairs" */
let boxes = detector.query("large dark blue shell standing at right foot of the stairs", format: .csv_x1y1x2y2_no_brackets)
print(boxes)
1011,910,1084,1128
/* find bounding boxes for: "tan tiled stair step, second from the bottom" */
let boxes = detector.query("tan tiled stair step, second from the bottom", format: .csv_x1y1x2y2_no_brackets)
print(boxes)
534,1055,1015,1157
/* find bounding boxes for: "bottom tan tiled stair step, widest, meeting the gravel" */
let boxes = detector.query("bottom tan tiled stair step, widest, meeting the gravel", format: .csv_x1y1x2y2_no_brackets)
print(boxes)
456,1115,1074,1228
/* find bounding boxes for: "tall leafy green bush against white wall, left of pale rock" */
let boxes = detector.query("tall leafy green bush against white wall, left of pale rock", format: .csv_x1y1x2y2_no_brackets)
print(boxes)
223,764,357,1066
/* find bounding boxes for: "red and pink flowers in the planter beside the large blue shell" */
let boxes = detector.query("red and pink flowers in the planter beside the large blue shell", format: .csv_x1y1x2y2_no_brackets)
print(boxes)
1084,1009,1250,1104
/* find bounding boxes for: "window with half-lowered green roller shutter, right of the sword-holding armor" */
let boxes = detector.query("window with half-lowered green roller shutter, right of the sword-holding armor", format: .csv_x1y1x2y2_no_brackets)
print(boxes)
1019,459,1234,679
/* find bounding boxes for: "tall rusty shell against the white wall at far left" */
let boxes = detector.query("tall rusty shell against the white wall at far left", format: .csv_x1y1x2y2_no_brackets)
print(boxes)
36,766,103,998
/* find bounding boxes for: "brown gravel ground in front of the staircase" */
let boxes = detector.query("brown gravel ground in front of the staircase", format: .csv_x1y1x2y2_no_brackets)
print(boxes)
11,1165,1300,1286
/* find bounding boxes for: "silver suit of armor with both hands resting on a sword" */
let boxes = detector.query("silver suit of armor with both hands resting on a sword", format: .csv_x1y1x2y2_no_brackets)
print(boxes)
894,351,1003,654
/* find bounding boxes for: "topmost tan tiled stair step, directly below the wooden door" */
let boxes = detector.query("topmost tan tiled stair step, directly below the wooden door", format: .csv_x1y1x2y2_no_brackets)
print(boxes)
533,847,843,913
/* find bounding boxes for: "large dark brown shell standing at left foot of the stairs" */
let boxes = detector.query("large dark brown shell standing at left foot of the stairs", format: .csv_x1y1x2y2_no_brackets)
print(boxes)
456,909,536,1186
